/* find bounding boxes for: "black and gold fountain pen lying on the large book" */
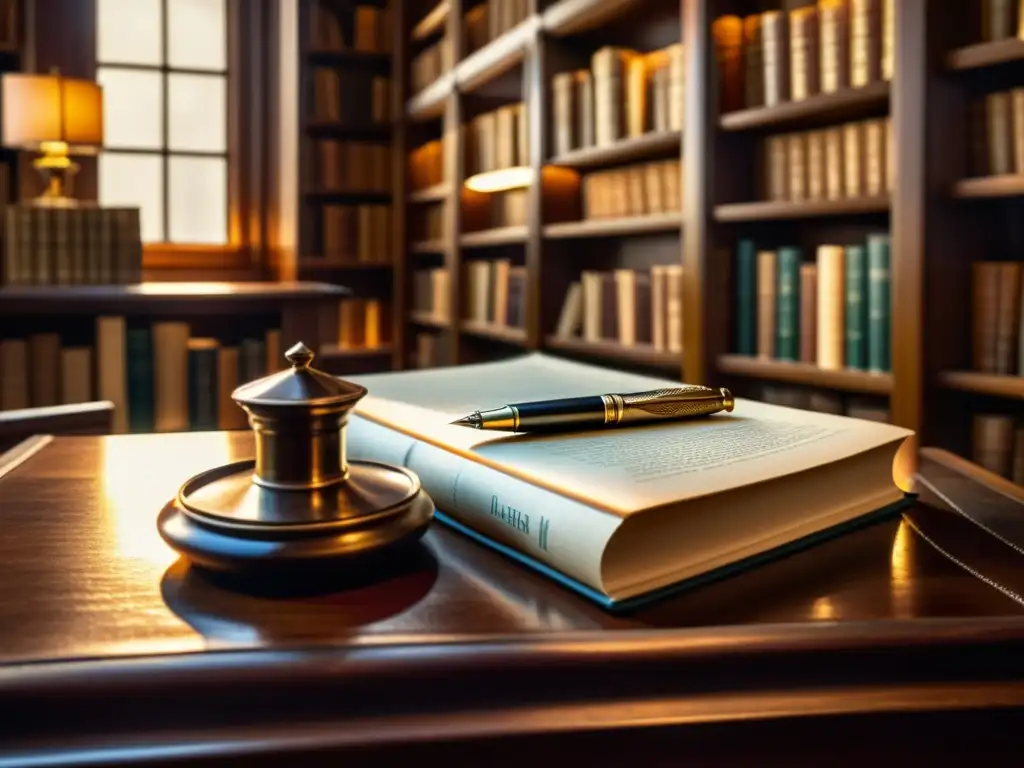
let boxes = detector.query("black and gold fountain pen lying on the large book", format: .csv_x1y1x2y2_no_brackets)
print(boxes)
452,385,734,432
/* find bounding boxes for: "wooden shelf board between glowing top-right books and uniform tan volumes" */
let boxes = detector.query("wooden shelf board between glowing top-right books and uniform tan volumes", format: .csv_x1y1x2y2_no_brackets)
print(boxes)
719,82,890,131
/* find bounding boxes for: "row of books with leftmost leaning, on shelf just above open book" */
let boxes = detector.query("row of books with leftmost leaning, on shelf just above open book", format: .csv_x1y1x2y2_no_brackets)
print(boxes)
555,264,683,353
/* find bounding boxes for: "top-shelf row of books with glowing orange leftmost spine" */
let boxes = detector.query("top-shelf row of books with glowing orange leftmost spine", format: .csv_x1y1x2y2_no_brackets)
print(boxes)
712,0,896,112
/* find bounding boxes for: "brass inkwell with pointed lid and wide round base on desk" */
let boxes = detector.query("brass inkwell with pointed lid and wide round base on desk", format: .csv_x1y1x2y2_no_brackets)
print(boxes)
158,342,434,575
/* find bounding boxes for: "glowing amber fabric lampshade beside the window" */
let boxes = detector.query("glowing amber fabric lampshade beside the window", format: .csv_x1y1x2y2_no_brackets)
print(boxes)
2,73,103,154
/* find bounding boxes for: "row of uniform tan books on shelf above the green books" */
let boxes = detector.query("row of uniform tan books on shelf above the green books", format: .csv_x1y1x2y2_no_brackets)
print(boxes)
763,118,895,201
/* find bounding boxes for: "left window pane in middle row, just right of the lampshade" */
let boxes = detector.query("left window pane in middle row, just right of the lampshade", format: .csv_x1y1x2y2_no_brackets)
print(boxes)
96,67,164,150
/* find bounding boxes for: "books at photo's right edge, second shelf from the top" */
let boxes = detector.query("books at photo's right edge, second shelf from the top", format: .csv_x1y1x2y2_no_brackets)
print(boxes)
969,88,1024,176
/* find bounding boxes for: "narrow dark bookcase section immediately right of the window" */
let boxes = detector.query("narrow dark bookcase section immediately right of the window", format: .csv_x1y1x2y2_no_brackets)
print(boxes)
294,0,406,373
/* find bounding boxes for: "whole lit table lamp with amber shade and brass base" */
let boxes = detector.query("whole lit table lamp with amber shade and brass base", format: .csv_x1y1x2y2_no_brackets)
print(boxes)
0,70,103,207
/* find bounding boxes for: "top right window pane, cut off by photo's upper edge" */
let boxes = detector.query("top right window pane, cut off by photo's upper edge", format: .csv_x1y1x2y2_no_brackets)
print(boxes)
167,0,227,70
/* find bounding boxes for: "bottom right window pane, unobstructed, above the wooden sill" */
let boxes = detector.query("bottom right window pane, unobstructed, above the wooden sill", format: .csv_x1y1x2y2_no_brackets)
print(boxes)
169,157,227,245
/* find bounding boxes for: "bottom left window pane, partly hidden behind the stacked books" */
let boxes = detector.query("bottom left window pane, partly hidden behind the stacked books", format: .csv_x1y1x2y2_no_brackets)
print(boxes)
99,152,164,243
